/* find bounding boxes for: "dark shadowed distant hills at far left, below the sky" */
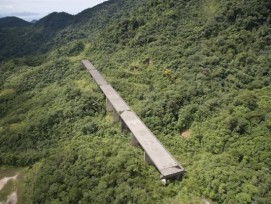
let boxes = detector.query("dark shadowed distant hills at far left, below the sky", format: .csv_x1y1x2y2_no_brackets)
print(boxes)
0,12,73,60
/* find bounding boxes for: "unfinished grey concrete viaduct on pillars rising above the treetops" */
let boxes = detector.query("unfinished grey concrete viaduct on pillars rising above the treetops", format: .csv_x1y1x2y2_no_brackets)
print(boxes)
82,60,184,183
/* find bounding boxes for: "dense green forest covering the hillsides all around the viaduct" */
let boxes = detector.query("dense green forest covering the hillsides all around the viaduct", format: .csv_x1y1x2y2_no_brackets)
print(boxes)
0,0,271,204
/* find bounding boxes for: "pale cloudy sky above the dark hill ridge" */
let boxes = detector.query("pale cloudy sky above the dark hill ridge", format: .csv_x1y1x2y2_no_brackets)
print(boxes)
0,0,106,21
